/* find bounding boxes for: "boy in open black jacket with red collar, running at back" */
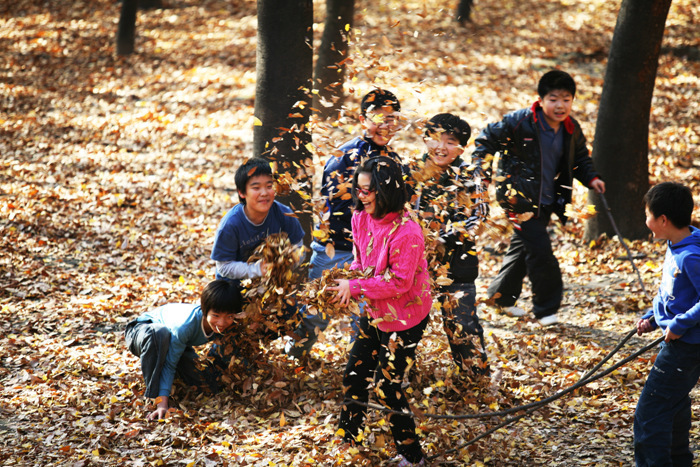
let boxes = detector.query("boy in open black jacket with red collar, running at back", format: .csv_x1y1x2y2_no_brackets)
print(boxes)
472,70,605,326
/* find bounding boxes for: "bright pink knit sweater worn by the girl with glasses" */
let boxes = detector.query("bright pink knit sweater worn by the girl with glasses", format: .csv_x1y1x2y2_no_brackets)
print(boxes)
350,211,432,332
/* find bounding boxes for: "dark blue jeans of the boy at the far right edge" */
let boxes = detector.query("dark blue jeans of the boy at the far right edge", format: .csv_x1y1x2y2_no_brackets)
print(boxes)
634,340,700,467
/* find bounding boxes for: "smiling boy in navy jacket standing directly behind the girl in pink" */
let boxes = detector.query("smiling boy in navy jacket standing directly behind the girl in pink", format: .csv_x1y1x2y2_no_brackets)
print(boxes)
290,89,401,355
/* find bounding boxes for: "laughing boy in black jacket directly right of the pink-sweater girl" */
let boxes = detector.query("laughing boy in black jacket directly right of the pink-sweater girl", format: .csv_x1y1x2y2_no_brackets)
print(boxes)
415,113,488,375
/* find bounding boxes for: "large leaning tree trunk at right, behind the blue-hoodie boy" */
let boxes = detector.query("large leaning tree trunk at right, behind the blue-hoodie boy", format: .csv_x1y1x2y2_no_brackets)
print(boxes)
585,0,671,240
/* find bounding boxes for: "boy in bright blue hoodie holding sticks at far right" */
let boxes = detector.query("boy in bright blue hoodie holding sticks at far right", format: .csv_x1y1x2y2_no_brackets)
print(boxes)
634,182,700,466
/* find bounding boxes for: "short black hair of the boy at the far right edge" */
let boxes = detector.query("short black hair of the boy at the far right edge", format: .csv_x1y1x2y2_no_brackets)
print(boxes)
644,182,693,229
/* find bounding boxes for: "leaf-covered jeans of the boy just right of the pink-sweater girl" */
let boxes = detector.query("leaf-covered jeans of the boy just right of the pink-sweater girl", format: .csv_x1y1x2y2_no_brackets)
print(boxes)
440,282,488,374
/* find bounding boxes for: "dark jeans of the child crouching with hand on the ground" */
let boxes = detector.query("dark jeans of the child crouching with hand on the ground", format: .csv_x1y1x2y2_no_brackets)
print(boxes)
124,320,219,398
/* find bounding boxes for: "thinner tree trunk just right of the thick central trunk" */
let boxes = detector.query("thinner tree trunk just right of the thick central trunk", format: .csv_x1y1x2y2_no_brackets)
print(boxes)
313,0,355,119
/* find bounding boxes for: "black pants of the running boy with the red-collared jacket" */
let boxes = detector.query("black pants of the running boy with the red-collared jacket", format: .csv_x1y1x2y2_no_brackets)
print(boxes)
488,206,564,318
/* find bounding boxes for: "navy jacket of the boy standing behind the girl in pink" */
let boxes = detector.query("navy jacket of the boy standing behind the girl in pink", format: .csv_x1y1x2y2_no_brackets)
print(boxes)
319,136,401,251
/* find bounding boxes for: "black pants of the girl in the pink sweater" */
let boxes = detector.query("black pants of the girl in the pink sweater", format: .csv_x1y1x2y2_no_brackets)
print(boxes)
339,315,429,462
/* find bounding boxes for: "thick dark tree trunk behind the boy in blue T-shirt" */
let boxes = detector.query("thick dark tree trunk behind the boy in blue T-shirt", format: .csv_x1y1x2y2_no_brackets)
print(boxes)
253,0,313,245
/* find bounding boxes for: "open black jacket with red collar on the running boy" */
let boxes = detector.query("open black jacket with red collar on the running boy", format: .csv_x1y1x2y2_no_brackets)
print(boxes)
472,102,598,222
